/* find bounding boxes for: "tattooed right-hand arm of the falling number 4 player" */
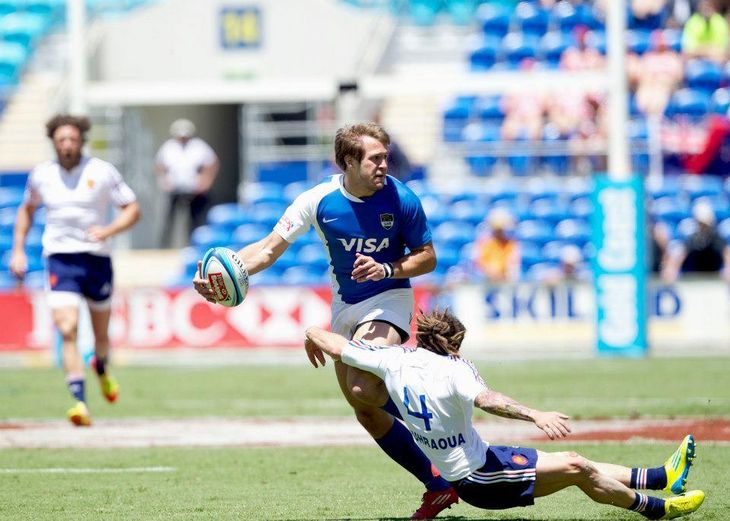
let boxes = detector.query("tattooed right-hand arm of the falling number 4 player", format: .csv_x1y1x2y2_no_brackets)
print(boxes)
474,389,570,440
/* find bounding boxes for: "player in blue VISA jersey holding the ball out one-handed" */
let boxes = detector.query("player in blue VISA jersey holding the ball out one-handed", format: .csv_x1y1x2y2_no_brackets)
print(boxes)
193,123,457,519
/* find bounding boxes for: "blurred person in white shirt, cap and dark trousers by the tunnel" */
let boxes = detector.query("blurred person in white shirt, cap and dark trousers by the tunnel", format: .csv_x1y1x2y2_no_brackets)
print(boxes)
155,119,220,248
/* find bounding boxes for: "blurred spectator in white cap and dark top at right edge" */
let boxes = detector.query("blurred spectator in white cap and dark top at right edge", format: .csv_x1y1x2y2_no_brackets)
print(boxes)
662,201,730,282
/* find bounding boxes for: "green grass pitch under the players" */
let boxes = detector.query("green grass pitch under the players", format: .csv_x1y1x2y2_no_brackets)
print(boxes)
0,358,730,521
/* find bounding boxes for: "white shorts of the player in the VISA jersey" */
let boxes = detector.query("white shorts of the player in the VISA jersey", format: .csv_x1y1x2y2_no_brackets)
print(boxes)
331,288,415,342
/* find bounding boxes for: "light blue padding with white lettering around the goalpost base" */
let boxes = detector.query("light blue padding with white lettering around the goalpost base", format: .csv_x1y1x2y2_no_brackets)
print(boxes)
592,175,648,356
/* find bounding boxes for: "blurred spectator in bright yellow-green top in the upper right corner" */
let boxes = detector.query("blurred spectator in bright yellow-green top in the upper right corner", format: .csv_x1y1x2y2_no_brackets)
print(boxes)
682,0,730,62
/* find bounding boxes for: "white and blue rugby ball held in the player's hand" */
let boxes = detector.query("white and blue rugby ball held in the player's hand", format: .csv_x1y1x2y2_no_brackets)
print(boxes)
201,248,248,307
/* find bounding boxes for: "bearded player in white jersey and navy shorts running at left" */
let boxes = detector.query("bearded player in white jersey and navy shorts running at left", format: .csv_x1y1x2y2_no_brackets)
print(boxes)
10,115,140,426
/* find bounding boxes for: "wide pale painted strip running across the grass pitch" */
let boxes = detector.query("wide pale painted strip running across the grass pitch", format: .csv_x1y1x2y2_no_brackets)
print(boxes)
0,417,724,450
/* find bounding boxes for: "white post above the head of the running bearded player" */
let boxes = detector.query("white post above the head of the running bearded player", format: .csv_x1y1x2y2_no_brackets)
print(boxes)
66,0,88,115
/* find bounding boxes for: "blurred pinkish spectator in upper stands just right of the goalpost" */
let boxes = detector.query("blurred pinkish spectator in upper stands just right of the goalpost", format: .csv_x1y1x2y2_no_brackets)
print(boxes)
627,29,684,115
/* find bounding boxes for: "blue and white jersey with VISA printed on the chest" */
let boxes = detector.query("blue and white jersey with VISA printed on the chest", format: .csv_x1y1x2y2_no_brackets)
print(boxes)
274,174,431,304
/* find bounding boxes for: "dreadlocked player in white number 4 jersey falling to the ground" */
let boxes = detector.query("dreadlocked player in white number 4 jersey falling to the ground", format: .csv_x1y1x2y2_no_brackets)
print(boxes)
305,311,705,519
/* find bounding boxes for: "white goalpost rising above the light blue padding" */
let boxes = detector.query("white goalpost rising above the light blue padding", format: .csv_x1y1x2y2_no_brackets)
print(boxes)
606,0,631,181
